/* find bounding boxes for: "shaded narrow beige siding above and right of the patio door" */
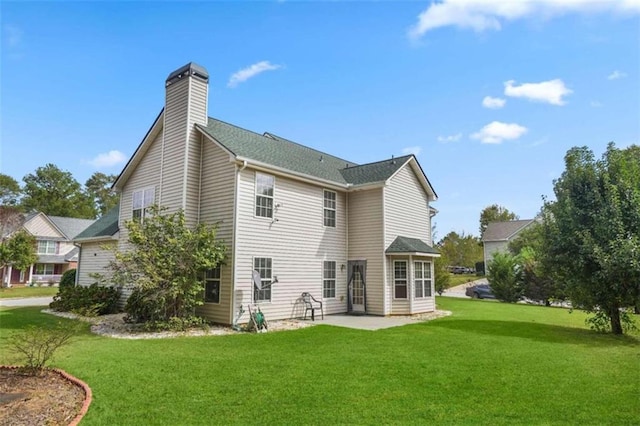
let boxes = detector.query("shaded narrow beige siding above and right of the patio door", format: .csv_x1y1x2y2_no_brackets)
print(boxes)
348,189,387,315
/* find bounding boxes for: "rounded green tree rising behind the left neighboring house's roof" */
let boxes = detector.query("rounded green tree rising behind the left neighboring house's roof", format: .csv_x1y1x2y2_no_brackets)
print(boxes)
22,164,96,219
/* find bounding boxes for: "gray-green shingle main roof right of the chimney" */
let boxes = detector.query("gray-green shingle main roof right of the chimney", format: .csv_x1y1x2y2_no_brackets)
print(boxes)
198,118,420,185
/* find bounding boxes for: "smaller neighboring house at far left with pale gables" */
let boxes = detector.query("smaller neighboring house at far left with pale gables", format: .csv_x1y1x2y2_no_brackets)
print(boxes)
2,213,94,286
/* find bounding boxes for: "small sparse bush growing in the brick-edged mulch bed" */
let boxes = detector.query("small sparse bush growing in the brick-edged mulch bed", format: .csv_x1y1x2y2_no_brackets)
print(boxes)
8,323,80,375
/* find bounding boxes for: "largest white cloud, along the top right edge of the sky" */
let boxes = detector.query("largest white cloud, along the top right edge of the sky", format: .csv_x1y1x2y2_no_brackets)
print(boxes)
408,0,640,39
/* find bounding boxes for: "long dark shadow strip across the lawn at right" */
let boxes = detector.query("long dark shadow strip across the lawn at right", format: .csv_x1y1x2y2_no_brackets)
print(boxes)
429,319,640,347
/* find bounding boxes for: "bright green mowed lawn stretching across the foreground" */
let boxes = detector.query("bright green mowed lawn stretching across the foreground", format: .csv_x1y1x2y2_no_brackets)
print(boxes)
0,297,640,425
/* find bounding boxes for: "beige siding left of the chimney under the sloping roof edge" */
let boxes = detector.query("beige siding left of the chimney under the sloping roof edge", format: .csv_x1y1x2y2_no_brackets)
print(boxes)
118,128,162,250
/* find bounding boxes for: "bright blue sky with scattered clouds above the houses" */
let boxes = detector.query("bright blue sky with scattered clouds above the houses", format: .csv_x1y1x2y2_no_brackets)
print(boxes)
0,0,640,237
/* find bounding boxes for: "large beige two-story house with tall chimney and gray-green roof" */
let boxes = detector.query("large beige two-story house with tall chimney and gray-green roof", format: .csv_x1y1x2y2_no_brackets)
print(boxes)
77,63,438,324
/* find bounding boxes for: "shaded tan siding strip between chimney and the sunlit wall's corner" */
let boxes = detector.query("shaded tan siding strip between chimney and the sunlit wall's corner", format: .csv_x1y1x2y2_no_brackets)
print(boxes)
198,140,236,324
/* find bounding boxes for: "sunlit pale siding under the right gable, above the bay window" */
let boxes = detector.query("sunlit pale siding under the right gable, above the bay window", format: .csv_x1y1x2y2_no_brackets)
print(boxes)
384,164,431,249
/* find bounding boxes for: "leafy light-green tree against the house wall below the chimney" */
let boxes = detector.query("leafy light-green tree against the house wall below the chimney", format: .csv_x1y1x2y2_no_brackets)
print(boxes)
111,206,226,326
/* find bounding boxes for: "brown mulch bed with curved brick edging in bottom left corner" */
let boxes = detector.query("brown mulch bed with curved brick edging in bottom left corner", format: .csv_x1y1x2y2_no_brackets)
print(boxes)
0,366,91,426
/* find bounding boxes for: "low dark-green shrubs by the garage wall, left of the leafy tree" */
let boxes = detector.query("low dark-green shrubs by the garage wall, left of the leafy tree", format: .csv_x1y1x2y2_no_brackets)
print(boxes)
49,284,120,316
